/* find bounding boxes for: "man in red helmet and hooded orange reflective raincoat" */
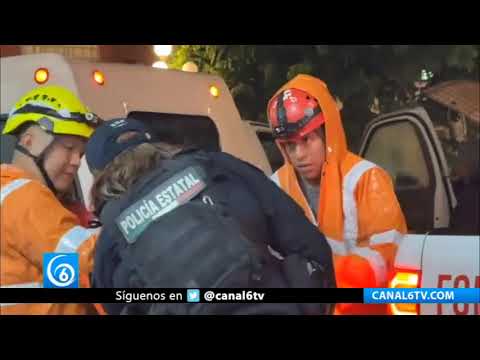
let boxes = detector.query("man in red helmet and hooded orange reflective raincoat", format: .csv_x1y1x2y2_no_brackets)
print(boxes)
267,75,407,314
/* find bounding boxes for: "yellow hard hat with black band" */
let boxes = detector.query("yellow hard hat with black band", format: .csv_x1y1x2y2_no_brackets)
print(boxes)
3,85,99,138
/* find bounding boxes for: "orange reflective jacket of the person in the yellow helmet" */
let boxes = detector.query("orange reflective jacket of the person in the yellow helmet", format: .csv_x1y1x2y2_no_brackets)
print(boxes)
0,164,97,315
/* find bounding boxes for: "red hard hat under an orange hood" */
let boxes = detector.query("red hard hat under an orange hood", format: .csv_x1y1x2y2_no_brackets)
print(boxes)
268,89,325,140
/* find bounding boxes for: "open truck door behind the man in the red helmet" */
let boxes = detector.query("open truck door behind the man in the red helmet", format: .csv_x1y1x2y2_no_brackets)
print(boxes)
360,108,457,233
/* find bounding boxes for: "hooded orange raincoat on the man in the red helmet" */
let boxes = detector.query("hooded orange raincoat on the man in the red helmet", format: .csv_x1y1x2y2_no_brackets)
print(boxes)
272,75,407,314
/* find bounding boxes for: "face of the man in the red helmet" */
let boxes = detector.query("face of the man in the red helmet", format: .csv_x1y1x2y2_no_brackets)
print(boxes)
284,130,325,185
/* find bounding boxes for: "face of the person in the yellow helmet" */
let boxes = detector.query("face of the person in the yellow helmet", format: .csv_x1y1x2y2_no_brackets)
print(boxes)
44,135,86,192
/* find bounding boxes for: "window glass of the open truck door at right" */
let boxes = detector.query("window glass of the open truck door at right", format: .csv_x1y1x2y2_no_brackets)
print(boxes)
365,121,435,233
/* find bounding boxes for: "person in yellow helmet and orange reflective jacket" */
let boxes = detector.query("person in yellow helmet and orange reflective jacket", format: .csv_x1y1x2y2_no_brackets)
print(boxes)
0,85,99,315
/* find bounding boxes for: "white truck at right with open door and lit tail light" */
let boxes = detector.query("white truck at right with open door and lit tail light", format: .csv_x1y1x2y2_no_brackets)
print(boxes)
360,97,480,315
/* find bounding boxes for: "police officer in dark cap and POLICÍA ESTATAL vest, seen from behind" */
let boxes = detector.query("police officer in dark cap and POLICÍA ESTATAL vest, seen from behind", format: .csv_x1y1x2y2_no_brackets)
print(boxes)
86,118,335,314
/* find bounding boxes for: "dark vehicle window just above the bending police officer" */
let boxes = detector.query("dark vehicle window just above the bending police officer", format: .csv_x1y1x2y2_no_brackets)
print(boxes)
128,111,221,151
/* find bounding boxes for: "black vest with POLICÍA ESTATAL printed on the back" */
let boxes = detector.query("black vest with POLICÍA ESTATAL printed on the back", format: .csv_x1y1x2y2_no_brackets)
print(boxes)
99,152,269,288
